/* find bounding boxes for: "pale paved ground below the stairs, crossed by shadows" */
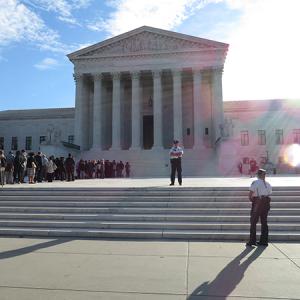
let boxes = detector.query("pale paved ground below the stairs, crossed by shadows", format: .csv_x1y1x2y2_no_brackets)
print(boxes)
0,238,300,300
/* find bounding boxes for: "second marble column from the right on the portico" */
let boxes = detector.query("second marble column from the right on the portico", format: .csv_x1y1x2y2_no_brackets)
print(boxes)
193,70,204,149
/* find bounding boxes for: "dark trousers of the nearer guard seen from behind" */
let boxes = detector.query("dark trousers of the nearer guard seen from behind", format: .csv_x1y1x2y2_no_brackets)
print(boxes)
250,197,271,244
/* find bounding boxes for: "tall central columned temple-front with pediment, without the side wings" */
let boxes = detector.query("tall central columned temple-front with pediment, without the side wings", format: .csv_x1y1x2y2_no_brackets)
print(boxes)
68,26,228,176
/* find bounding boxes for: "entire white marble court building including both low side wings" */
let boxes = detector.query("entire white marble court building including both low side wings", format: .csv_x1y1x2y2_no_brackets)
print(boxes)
0,26,300,177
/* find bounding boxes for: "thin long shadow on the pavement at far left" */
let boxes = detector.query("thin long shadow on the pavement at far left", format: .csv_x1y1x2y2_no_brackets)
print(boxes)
0,238,71,259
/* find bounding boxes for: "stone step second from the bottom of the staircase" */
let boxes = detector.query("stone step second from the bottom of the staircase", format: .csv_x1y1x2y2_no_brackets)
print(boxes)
0,220,300,232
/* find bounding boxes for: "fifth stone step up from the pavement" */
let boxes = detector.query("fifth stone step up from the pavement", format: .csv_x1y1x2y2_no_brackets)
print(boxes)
0,200,300,209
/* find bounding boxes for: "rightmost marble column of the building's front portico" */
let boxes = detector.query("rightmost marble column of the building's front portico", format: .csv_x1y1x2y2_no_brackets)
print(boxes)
212,69,224,146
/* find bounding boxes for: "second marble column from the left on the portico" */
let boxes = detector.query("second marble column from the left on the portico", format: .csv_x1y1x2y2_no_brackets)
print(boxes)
93,74,103,149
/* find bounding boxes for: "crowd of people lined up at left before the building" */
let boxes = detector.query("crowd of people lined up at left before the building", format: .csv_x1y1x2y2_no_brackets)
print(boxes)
0,150,130,186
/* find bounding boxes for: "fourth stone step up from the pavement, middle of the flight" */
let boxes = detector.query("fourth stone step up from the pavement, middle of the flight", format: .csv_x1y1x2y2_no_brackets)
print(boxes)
0,206,300,216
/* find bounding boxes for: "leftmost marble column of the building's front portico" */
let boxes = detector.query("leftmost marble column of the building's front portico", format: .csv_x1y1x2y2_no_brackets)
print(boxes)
73,73,84,150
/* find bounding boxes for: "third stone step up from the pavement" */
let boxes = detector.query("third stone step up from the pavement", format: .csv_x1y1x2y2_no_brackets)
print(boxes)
0,212,300,223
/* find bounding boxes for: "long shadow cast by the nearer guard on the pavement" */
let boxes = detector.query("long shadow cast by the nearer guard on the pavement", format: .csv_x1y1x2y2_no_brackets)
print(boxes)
187,247,265,300
